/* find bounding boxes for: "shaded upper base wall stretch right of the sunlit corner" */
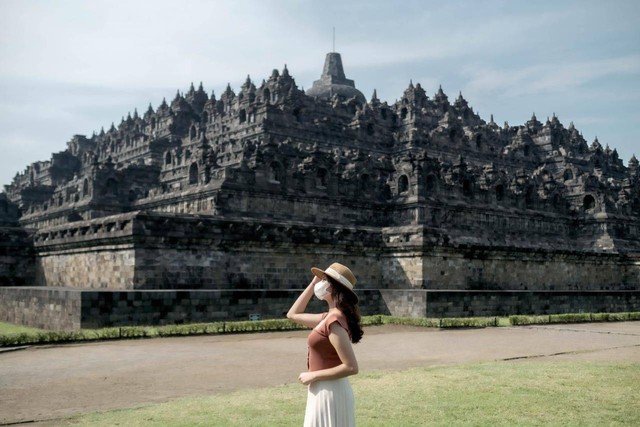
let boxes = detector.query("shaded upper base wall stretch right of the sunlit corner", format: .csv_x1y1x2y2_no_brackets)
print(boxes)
422,247,640,290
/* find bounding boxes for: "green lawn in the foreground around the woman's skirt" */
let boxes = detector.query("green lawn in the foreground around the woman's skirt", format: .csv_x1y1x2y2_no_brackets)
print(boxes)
51,361,640,427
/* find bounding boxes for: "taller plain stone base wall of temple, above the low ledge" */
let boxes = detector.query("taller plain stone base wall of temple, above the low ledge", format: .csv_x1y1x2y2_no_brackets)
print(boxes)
26,212,640,290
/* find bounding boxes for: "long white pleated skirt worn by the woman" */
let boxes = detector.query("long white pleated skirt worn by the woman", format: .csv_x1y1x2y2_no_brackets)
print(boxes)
304,378,356,427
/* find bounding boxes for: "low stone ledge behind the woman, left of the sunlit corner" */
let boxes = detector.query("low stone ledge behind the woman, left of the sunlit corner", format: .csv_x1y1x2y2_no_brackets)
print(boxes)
0,287,386,330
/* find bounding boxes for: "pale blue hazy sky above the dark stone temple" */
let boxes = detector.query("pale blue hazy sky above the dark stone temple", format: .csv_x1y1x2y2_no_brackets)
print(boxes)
0,0,640,188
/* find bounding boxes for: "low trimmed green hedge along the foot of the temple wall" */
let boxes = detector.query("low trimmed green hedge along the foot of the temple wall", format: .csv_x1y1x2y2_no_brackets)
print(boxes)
0,312,640,347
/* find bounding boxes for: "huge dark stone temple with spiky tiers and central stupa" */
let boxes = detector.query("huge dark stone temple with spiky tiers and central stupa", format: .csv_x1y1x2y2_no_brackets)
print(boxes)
0,53,640,329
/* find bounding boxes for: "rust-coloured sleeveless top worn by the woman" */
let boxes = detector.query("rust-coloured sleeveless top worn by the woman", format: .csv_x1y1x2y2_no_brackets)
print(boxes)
307,312,351,371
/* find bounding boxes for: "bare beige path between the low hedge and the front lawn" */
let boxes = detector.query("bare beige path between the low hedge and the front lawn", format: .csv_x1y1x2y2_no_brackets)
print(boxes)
0,322,640,427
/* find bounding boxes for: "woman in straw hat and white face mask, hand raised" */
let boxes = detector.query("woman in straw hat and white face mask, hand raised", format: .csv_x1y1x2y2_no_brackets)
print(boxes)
287,262,363,427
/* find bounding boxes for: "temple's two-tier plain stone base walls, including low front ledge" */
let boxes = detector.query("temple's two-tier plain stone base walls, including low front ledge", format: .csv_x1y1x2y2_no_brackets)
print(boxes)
11,212,640,329
